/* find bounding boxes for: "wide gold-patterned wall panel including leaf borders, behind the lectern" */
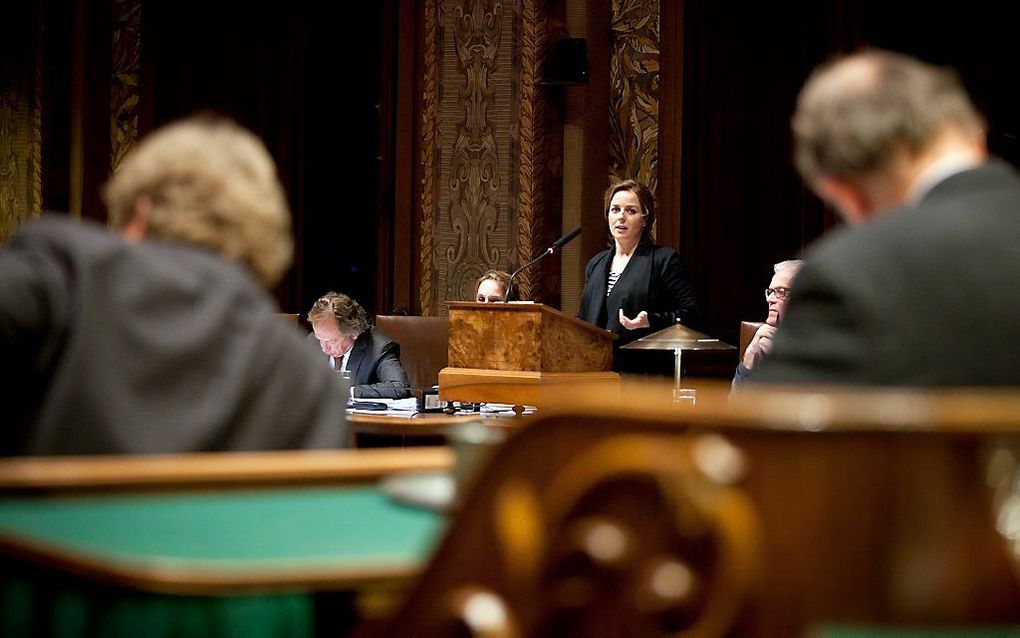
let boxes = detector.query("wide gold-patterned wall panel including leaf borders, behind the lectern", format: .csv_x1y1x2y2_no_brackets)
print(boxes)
419,0,546,314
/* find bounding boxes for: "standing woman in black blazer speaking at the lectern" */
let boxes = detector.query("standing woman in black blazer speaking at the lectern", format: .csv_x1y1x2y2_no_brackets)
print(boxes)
577,180,700,369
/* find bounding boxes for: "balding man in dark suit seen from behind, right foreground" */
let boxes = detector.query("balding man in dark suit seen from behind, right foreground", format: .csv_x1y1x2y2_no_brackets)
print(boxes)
755,51,1020,386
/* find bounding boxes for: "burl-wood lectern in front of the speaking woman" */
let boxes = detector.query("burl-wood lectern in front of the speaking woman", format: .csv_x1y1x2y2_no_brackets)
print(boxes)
440,301,620,405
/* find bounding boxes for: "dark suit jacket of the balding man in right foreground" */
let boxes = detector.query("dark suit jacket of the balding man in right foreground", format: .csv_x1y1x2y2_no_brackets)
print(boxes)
753,161,1020,386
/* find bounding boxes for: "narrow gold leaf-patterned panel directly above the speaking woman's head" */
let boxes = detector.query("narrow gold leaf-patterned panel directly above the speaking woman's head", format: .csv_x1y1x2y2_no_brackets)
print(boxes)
609,0,659,193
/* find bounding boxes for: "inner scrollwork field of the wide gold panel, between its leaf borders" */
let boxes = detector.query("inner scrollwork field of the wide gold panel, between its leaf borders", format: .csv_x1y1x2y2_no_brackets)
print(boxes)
435,0,513,302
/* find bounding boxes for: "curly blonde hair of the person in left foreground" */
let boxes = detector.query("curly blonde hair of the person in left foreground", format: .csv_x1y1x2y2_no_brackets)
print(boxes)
103,115,294,288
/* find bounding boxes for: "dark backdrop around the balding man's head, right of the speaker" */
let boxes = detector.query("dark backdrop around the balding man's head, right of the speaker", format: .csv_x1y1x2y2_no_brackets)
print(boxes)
677,0,1020,343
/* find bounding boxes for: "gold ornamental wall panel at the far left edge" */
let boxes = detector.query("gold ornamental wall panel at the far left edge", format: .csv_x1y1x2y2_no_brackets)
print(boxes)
0,3,43,242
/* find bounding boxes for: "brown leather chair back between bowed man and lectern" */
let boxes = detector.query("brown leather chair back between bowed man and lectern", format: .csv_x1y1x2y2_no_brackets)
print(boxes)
375,314,450,388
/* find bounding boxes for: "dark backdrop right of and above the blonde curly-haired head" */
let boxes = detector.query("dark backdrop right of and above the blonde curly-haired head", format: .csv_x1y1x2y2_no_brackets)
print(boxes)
142,0,383,312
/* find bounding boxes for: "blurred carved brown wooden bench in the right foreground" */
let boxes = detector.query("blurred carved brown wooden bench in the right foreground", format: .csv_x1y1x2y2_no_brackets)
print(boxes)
369,379,1020,636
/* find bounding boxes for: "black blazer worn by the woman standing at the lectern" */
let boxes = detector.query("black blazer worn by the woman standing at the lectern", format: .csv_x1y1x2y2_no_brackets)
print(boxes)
577,241,701,345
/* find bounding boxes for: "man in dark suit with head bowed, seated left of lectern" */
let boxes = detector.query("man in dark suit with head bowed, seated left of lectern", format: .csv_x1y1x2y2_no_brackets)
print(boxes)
308,291,411,399
